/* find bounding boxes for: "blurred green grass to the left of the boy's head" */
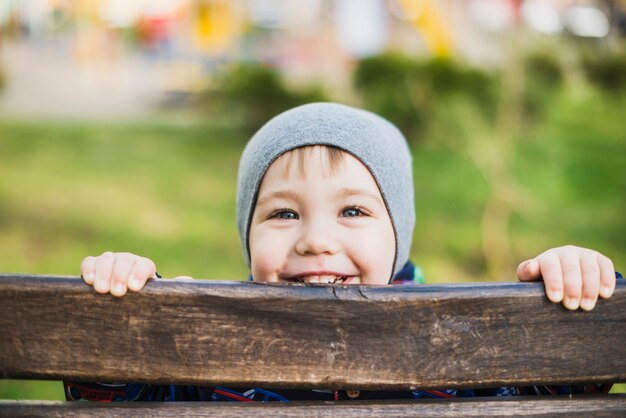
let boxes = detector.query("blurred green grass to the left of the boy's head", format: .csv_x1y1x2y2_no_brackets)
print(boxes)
0,121,247,279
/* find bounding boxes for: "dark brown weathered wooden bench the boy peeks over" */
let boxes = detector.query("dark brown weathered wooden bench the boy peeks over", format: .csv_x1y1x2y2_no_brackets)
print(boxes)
0,275,626,417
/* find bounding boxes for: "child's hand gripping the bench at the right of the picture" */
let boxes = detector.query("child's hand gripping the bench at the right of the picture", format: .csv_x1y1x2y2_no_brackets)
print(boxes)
517,245,615,311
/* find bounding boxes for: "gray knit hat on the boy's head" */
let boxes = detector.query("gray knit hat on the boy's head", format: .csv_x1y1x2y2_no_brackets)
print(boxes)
237,103,415,275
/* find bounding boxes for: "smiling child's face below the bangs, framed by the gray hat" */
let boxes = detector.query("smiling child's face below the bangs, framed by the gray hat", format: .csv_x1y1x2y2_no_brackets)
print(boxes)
249,146,395,284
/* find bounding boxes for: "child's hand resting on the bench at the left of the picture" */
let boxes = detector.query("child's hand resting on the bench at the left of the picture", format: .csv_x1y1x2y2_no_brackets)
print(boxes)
80,252,156,296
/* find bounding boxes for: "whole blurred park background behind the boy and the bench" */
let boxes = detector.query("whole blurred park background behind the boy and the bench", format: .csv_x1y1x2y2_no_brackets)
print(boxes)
0,0,626,399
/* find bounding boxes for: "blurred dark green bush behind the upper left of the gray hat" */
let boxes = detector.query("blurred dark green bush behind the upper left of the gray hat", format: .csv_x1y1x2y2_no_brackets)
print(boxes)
199,64,329,135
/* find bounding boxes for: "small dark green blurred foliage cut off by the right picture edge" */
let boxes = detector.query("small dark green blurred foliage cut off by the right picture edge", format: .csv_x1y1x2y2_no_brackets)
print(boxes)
582,49,626,94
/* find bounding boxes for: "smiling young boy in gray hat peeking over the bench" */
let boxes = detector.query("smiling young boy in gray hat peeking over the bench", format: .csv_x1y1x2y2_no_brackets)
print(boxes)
66,103,615,400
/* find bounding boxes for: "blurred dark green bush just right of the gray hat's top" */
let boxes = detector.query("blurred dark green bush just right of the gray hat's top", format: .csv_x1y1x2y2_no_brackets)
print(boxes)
354,53,498,142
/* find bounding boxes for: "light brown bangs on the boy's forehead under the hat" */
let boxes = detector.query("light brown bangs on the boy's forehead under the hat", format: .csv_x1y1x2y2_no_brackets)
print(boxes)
279,145,346,178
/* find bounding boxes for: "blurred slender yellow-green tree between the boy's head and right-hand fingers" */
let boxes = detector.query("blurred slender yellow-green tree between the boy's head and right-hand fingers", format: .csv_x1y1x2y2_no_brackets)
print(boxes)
424,49,543,280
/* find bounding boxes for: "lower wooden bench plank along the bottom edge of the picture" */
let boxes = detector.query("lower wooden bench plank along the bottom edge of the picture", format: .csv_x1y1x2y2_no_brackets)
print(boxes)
0,395,626,418
